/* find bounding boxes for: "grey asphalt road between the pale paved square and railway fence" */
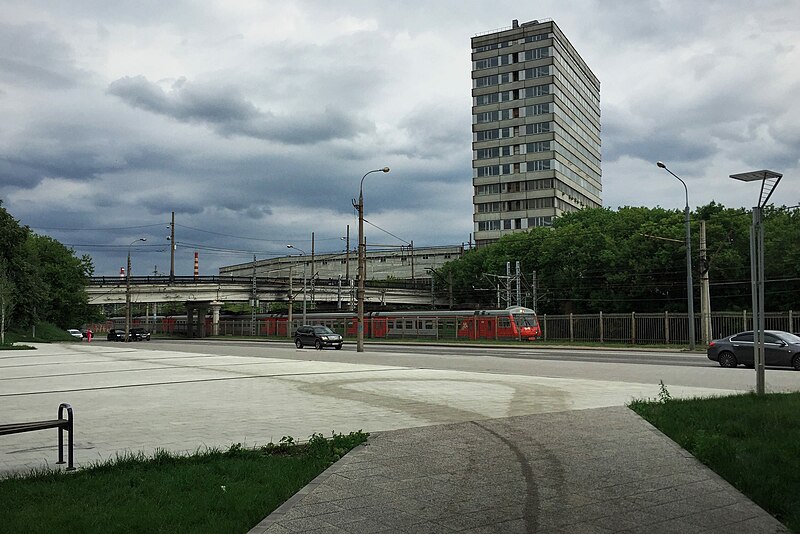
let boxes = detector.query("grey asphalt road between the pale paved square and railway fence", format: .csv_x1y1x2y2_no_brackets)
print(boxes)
112,339,800,391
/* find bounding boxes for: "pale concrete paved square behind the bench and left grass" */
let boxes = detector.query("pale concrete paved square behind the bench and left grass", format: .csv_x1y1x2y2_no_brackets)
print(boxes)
0,343,728,474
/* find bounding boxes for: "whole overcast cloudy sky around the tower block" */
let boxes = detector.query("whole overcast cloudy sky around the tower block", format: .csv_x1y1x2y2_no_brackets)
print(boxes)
0,0,800,275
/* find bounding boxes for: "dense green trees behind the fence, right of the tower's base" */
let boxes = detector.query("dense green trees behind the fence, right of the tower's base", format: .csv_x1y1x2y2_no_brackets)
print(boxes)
437,202,800,313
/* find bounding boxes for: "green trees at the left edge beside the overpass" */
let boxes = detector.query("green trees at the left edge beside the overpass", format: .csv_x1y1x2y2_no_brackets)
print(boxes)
0,200,94,340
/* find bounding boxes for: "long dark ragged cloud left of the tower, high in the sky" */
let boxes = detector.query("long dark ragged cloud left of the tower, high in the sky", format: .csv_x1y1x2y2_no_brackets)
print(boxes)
108,76,368,145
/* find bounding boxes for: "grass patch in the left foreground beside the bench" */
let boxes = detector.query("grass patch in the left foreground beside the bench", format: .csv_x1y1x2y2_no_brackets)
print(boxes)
0,431,369,533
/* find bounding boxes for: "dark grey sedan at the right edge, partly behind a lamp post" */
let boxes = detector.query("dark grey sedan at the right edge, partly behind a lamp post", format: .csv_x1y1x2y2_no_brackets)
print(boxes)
706,330,800,371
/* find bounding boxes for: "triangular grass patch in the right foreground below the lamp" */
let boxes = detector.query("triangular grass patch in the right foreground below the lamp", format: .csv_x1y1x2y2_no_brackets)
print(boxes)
630,385,800,532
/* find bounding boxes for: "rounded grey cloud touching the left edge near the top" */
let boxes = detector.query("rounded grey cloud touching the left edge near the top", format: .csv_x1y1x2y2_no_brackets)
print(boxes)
0,22,85,89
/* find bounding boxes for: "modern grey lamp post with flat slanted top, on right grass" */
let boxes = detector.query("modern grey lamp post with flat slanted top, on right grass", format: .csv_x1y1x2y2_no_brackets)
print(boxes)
730,170,783,395
